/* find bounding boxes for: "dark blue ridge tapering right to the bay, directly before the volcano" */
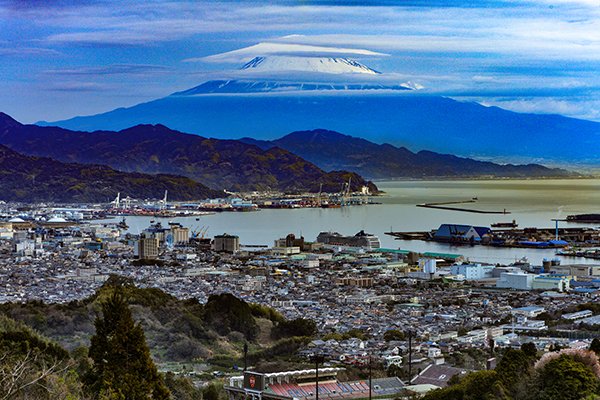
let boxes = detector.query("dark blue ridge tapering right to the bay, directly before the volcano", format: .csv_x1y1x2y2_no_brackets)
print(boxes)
241,129,577,179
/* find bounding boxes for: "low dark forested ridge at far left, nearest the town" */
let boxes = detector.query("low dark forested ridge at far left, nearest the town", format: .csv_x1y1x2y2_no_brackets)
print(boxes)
0,145,224,203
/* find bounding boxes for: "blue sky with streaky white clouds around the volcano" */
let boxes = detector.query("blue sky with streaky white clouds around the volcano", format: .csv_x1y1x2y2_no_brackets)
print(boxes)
0,0,600,123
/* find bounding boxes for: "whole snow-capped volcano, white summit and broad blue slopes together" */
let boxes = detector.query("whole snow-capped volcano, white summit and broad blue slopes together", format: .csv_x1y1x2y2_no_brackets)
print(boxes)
38,45,600,167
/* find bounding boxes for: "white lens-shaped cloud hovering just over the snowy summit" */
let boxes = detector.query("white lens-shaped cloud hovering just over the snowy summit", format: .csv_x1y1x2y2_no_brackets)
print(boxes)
184,42,388,63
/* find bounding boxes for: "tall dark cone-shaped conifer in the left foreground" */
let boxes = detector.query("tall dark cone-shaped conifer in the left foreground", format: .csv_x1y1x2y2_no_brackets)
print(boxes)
88,287,170,400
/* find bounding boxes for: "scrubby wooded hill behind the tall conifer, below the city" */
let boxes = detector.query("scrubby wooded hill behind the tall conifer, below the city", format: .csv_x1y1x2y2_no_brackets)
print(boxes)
0,276,316,366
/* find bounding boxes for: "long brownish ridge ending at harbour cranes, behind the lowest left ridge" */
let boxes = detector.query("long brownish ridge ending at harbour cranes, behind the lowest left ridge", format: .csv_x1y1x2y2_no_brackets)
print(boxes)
0,113,377,192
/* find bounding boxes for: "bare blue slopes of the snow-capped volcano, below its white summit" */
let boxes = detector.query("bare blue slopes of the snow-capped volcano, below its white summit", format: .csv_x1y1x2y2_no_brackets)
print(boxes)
41,92,600,165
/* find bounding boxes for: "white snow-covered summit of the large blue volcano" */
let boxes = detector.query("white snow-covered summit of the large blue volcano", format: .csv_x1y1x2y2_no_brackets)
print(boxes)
242,56,379,75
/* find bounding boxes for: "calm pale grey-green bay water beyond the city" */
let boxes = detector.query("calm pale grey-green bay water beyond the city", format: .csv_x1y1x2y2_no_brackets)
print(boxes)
111,179,600,263
